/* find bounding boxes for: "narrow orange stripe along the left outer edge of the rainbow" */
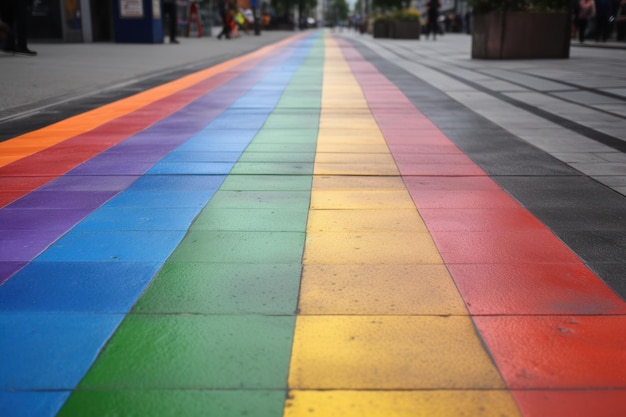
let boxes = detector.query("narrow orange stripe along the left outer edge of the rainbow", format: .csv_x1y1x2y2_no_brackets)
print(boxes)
0,35,304,167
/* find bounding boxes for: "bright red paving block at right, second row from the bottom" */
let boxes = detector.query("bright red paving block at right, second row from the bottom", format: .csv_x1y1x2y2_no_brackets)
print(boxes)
474,316,626,390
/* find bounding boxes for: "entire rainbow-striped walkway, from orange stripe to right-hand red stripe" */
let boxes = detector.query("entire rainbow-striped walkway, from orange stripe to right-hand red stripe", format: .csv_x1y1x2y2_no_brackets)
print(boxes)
0,31,626,417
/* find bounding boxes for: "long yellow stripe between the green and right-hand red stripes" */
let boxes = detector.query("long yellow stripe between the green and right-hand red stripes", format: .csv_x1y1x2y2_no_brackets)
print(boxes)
284,37,519,417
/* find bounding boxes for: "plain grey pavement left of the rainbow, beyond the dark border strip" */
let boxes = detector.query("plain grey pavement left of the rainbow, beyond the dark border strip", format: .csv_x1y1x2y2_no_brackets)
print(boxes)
0,31,293,122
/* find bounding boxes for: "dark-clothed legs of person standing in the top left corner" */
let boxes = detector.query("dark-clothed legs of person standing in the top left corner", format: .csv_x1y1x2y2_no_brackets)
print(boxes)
0,0,37,56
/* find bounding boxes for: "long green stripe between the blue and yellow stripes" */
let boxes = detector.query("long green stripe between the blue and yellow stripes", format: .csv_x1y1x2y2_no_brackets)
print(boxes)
60,38,323,417
